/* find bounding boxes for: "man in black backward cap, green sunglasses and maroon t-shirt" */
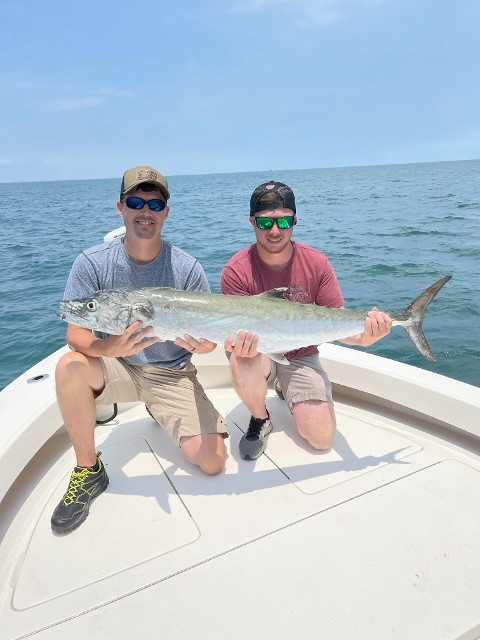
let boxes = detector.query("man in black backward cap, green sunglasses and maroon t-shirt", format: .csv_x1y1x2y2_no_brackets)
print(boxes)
221,181,392,460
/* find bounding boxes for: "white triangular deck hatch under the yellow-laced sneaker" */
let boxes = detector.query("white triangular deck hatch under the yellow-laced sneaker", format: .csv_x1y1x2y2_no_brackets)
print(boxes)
13,438,199,609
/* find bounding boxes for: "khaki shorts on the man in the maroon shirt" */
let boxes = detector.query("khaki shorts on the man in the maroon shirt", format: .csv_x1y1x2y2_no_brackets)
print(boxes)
267,355,333,411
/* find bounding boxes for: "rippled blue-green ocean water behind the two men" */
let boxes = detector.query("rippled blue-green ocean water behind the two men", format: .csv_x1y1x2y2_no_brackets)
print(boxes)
0,160,480,388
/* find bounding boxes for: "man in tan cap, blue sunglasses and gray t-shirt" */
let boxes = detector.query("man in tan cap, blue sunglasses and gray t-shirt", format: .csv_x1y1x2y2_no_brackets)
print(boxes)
51,166,228,533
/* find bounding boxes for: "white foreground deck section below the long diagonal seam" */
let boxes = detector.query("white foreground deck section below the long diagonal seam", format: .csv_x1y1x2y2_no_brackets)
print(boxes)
8,460,480,640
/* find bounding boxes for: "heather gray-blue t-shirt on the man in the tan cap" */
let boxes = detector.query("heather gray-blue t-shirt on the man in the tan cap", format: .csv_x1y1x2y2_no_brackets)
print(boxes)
63,238,210,369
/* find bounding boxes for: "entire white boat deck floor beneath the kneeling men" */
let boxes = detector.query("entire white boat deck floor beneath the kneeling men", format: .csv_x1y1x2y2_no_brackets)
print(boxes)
0,388,480,640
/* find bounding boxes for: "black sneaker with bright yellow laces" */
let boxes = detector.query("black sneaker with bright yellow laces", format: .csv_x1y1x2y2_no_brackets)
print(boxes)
51,451,109,533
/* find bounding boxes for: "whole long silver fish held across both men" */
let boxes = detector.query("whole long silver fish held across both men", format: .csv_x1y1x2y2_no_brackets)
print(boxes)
57,276,451,363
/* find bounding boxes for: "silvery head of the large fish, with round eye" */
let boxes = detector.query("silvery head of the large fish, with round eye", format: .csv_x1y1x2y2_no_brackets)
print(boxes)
57,289,154,335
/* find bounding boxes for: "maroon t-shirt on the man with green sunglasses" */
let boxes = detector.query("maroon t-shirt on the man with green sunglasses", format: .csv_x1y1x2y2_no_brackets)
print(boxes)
220,242,344,360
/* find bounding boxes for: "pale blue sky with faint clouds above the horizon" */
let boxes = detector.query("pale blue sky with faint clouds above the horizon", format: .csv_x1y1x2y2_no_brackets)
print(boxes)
0,0,480,182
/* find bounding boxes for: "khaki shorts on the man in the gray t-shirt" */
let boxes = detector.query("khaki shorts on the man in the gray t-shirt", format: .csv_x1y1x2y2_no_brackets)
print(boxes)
96,358,228,446
